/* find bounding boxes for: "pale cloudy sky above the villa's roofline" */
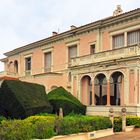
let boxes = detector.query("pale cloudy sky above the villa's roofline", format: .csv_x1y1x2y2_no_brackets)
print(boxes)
0,0,140,71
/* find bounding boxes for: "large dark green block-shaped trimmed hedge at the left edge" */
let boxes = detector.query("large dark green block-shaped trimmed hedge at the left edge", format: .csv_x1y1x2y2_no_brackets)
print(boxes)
0,80,52,118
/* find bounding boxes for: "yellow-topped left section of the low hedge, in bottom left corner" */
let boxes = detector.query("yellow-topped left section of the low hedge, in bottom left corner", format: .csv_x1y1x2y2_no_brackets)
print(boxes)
0,116,55,140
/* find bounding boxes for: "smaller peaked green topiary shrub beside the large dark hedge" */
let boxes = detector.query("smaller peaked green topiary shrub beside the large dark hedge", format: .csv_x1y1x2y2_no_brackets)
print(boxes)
47,87,86,115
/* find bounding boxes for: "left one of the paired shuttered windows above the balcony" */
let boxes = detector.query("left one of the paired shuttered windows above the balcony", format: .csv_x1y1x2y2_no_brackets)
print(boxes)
113,34,124,49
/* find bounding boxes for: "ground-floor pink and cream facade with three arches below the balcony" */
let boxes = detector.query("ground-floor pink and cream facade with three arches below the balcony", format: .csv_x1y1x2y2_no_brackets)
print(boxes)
72,68,140,116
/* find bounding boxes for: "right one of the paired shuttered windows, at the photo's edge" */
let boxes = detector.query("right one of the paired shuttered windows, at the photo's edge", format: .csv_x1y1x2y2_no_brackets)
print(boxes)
127,30,140,45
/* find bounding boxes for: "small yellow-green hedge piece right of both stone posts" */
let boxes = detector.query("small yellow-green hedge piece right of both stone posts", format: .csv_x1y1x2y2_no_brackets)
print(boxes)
126,116,140,128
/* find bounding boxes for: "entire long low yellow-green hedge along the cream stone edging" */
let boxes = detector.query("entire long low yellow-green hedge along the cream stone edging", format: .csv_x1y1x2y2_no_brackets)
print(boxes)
0,115,111,140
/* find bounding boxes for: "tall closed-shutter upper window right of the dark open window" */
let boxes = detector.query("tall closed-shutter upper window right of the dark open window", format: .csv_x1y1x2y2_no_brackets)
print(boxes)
44,52,52,72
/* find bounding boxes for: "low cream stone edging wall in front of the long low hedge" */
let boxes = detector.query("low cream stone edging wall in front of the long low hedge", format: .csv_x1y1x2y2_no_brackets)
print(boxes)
34,128,114,140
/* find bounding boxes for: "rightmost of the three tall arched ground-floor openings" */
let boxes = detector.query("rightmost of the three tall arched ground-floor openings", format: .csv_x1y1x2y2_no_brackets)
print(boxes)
110,72,123,105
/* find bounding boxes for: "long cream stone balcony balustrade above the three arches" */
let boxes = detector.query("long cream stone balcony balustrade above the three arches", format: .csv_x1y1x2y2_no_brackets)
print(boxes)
69,45,140,67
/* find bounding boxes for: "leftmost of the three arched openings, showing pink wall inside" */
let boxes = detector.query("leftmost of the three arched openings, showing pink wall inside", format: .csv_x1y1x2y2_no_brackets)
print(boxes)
81,75,92,105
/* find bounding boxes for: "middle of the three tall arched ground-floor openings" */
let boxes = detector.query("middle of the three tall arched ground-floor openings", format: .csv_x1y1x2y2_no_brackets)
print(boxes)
94,74,107,105
